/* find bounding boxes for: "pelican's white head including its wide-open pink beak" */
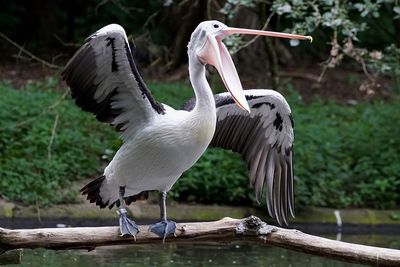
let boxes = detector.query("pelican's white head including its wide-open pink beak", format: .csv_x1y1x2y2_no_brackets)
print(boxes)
188,20,312,112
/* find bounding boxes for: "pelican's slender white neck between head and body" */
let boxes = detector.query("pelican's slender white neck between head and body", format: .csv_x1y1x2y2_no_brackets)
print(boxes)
189,58,215,115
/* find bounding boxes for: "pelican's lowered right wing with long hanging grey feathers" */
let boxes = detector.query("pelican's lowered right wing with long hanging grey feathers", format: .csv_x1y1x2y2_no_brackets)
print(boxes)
183,90,294,224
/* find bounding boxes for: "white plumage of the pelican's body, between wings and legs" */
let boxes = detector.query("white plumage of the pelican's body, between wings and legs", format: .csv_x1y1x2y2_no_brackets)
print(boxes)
100,109,215,203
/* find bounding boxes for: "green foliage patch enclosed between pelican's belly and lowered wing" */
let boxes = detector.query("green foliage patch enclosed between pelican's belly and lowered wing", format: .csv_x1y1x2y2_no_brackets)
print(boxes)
171,149,253,205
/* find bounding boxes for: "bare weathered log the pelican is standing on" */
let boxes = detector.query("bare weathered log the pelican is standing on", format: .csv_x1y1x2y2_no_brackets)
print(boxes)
0,216,400,266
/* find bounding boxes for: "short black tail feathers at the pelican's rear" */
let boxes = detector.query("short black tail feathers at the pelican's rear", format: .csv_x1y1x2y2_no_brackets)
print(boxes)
80,175,149,209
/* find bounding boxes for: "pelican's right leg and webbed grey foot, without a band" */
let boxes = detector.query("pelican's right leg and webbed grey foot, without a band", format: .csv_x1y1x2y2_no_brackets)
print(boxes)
149,192,176,242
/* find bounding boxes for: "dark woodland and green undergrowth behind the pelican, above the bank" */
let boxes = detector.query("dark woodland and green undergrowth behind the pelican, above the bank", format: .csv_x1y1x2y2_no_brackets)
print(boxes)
0,0,400,218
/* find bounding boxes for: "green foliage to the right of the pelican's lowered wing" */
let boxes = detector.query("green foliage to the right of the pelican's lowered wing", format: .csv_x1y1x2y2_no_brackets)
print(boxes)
292,91,400,208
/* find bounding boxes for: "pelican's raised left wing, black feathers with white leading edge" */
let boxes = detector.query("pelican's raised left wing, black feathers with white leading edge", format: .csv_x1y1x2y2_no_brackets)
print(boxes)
62,24,165,139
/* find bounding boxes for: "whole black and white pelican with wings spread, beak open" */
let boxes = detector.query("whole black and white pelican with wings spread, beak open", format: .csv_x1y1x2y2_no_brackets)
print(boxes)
62,21,311,239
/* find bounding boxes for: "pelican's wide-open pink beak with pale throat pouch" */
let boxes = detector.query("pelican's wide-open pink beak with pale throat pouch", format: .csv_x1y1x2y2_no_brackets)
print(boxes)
197,27,312,113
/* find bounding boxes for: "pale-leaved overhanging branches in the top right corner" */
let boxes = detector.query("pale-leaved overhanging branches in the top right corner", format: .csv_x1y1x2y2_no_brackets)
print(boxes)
220,0,400,92
